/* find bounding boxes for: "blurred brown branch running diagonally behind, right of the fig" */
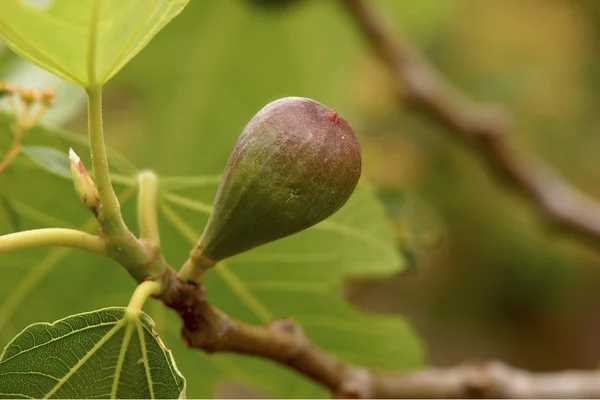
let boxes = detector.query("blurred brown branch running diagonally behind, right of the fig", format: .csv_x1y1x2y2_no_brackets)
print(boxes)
342,0,600,250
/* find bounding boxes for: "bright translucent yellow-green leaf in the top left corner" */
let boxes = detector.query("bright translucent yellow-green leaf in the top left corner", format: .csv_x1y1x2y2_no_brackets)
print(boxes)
0,0,188,87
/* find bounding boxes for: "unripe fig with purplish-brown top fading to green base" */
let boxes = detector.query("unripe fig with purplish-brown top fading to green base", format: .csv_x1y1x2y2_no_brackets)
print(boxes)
198,97,361,263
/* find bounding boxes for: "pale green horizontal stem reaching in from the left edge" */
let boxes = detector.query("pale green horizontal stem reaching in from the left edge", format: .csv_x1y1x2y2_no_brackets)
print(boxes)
0,228,107,256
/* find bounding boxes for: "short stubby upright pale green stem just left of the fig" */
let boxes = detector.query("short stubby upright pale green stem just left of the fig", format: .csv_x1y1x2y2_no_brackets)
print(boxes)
138,171,160,249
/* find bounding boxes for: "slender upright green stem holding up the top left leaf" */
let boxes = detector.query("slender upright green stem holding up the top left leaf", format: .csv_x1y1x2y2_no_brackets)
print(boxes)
87,87,129,238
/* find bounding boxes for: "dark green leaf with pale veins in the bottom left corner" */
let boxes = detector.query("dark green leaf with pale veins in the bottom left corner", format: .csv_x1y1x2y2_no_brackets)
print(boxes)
0,307,185,399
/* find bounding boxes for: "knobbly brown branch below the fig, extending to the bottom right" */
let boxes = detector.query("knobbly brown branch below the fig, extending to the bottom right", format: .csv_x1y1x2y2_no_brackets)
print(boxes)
160,269,600,398
